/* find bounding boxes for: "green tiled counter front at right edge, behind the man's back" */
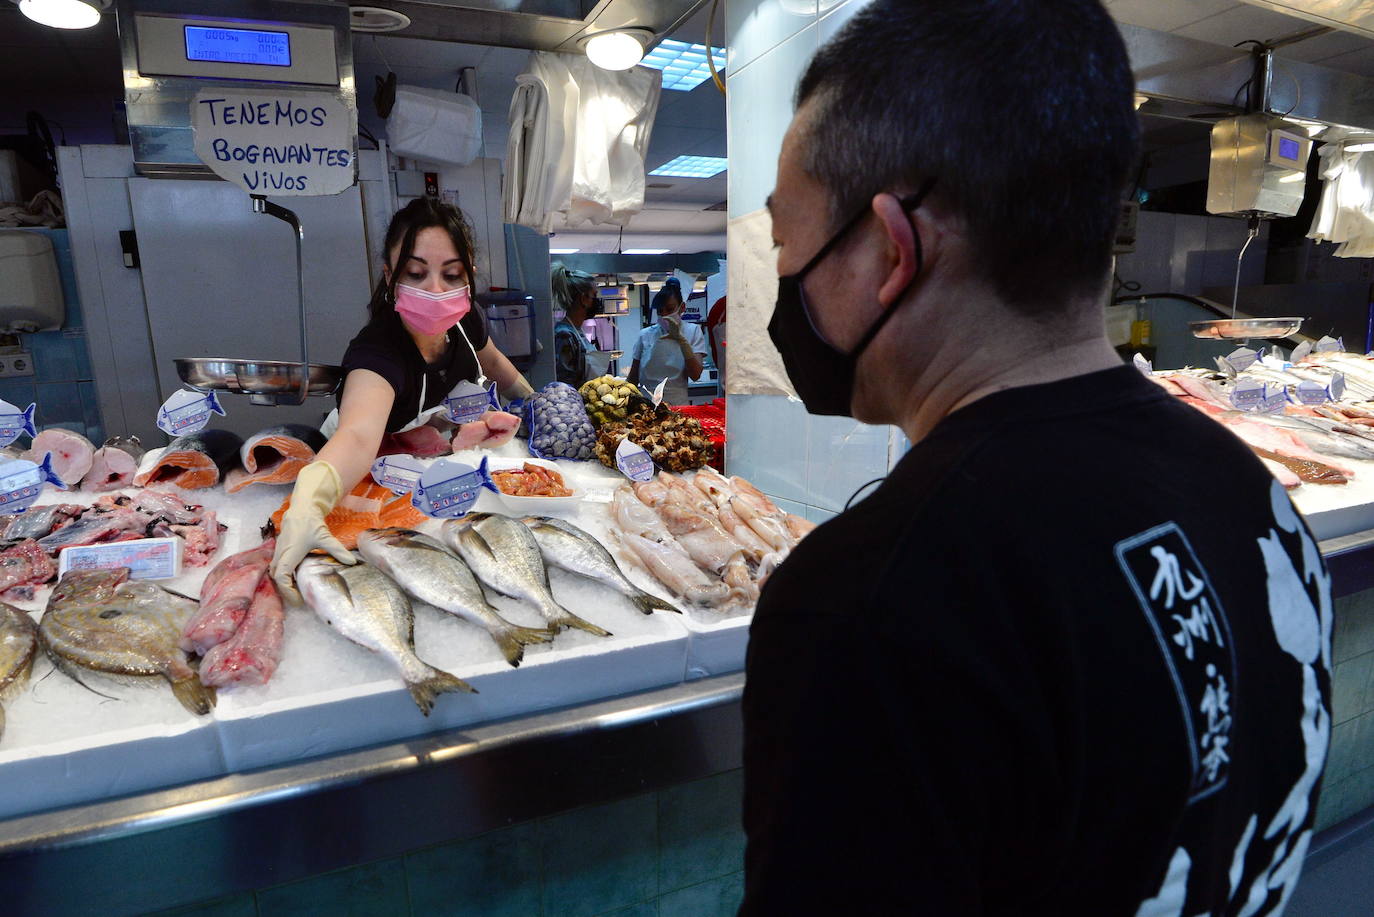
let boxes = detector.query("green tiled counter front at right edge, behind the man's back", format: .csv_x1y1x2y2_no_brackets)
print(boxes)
1316,590,1374,830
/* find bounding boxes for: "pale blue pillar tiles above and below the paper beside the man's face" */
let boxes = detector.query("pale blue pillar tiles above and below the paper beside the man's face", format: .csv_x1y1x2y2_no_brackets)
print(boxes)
725,0,907,522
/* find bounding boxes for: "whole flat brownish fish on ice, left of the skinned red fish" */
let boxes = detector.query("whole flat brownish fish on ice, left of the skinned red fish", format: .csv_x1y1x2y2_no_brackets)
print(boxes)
38,566,214,715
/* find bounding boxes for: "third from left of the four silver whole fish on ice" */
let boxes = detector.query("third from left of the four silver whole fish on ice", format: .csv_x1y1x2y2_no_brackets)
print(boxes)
442,513,610,637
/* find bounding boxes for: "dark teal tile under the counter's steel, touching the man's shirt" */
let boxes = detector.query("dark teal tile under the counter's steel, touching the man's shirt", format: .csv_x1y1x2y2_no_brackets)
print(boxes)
658,770,745,891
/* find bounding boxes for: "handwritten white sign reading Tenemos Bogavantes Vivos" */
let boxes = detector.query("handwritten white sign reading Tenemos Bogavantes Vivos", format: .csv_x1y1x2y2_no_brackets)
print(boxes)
191,87,357,197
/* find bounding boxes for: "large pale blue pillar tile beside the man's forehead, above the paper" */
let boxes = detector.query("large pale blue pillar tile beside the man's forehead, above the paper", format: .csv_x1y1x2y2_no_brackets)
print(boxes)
725,24,816,217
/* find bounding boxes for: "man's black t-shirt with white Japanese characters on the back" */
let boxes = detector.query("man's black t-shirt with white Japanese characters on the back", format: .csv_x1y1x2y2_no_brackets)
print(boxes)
741,367,1331,917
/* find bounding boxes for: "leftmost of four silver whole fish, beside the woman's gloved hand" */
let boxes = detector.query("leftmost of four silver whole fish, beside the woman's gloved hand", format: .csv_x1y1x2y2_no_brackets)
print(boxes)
295,555,477,716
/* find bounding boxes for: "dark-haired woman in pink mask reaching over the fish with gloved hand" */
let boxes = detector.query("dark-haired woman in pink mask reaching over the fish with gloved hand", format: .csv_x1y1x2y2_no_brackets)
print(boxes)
272,198,532,594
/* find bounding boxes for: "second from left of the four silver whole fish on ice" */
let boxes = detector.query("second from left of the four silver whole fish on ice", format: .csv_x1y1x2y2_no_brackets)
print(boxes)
357,528,554,665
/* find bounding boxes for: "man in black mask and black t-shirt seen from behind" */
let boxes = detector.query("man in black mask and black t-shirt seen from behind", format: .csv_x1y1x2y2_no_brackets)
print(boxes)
741,0,1331,917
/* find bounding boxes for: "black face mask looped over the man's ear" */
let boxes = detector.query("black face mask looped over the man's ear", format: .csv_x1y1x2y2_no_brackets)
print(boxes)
768,179,934,417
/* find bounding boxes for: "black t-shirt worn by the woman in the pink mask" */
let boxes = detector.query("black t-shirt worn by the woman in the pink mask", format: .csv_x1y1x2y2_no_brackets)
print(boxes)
338,307,488,433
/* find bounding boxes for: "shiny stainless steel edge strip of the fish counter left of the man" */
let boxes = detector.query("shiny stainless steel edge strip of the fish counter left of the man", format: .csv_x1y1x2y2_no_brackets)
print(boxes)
0,672,745,858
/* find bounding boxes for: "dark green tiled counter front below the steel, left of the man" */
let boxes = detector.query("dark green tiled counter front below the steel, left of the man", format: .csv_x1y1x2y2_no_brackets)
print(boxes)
148,770,745,917
